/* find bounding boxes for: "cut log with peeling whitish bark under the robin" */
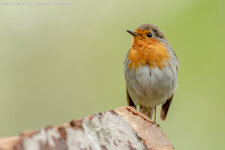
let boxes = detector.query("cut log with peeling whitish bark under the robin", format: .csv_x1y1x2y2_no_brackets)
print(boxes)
0,106,174,150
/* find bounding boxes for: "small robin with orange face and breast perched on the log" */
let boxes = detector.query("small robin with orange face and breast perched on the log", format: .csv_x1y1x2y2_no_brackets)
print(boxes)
124,24,178,122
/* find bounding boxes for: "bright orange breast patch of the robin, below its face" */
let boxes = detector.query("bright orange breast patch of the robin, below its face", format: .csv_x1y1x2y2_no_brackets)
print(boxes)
128,39,170,69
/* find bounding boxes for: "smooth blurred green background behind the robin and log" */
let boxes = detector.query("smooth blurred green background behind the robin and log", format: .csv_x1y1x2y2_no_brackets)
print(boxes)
0,0,225,150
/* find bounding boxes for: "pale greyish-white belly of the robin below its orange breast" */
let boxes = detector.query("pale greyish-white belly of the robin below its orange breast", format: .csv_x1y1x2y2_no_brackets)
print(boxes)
124,62,177,108
